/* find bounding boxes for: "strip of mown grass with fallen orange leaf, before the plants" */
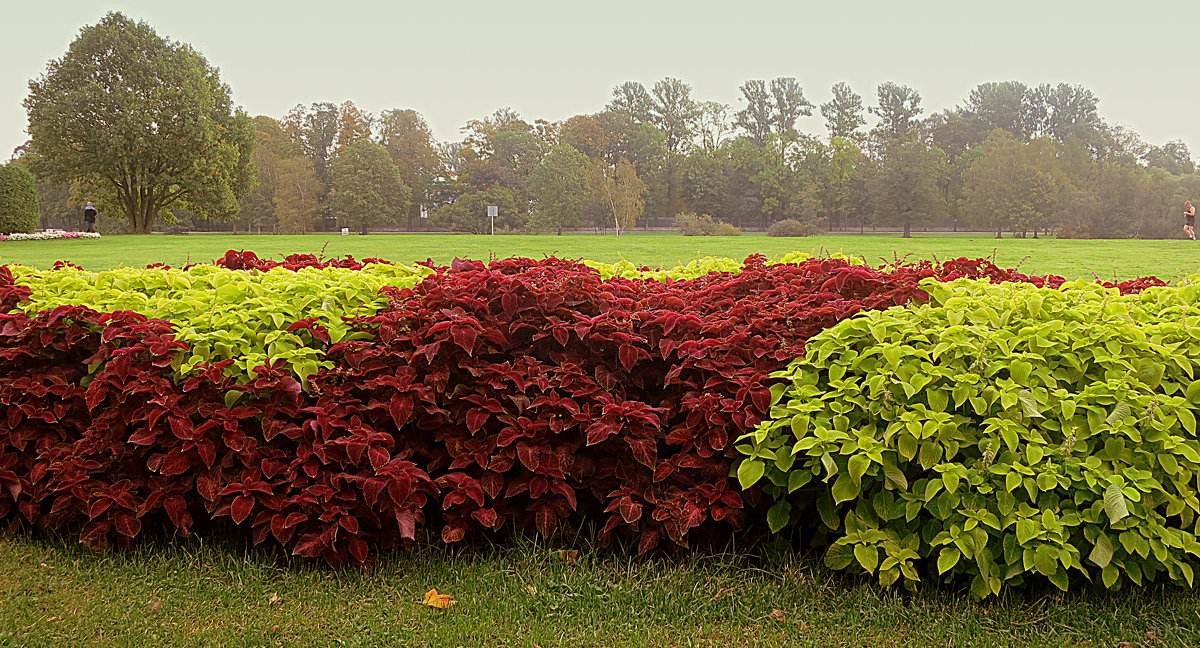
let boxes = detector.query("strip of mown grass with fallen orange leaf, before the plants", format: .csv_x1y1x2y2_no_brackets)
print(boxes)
0,535,1200,648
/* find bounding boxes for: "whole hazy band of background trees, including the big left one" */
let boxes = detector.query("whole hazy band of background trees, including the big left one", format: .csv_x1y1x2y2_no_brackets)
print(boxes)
11,13,1200,238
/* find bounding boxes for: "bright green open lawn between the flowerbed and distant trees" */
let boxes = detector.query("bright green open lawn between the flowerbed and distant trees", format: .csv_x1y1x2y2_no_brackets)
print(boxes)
0,233,1200,280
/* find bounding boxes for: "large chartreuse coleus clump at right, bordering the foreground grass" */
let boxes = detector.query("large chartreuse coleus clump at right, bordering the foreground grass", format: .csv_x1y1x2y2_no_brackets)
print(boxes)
734,280,1200,598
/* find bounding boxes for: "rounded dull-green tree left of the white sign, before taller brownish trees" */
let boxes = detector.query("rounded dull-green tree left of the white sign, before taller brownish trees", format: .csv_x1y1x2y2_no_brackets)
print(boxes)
329,139,412,234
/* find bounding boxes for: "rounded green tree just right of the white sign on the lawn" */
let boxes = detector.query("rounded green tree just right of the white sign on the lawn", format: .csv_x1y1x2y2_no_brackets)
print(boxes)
529,144,589,234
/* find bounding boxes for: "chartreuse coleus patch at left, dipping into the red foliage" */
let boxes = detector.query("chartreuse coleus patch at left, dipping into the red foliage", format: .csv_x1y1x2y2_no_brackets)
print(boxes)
10,264,432,379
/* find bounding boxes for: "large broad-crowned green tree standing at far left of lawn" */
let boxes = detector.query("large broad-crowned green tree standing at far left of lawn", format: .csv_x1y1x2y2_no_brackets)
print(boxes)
24,12,254,233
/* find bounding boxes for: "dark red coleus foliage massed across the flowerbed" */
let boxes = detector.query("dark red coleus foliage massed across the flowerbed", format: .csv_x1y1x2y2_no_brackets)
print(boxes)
0,252,1162,564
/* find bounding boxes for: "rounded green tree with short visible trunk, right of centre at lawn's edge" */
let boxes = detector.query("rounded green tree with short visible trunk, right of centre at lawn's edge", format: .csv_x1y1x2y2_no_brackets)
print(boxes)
870,140,946,239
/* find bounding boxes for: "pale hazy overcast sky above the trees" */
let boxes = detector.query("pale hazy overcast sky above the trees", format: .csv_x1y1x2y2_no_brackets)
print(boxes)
0,0,1200,160
